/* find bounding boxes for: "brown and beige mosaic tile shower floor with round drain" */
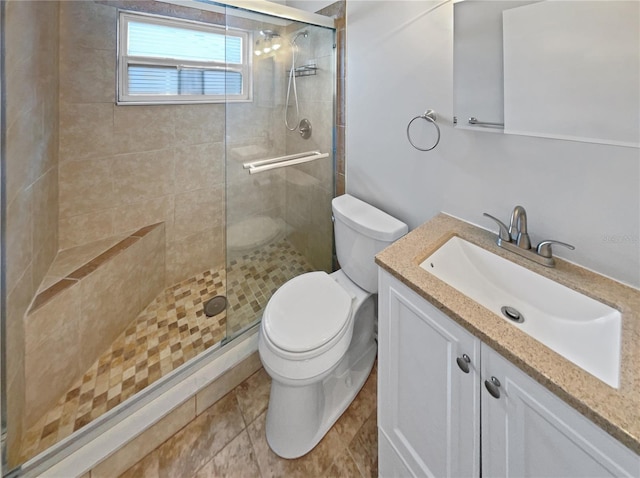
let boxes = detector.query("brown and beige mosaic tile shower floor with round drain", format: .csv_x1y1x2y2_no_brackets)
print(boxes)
21,239,313,461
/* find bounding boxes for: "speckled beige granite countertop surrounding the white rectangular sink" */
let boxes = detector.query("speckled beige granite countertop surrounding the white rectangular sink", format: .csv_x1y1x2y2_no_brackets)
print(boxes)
376,214,640,454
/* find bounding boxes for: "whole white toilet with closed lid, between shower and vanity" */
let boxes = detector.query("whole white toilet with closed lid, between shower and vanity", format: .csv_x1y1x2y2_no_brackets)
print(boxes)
258,194,408,458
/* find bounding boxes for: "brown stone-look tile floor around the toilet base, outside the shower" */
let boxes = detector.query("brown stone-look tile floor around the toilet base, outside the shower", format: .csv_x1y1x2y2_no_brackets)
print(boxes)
121,360,378,478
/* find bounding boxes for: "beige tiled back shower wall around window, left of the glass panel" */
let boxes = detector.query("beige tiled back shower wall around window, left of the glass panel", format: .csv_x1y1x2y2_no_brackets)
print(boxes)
59,1,225,284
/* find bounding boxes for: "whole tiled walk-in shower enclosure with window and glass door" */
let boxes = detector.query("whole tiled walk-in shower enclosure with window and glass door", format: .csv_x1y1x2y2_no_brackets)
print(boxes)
1,0,336,471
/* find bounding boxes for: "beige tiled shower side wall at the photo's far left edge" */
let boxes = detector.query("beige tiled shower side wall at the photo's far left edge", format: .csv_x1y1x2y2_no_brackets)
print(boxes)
4,1,58,464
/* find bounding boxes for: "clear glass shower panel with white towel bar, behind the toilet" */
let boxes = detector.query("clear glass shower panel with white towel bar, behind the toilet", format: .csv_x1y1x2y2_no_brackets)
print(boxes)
225,8,336,340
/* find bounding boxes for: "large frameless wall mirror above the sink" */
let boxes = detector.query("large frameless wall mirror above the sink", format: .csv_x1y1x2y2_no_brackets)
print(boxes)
454,0,640,147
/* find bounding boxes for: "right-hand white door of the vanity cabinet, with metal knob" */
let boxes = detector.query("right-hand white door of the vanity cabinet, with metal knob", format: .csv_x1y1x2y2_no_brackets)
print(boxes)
481,344,640,478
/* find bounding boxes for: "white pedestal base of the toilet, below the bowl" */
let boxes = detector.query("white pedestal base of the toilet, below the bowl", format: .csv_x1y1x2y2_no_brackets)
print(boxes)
266,340,377,459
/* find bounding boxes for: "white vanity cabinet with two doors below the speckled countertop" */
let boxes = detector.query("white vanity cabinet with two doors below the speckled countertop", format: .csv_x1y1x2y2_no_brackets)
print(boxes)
378,269,640,478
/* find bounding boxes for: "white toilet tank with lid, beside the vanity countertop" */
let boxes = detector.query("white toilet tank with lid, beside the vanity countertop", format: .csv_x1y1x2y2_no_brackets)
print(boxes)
331,194,409,293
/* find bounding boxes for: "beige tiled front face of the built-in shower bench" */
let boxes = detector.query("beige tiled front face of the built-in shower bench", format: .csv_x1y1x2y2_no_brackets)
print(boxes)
24,224,165,427
